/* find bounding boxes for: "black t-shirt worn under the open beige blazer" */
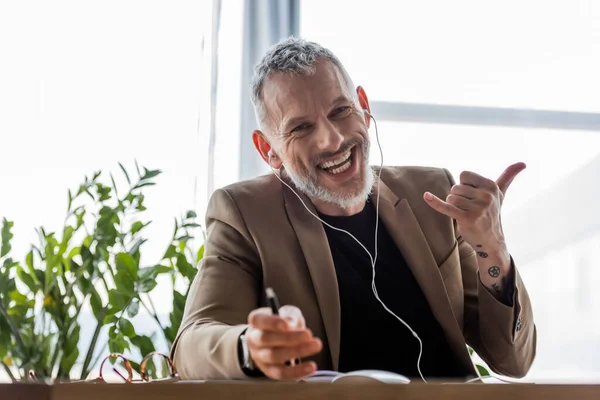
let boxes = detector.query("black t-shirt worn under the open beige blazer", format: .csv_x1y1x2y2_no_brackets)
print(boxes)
320,201,469,378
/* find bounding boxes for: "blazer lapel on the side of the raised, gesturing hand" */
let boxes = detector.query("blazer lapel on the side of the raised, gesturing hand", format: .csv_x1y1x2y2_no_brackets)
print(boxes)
371,182,473,369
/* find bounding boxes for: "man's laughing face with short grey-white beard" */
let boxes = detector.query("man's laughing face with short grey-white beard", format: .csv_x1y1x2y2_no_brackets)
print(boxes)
259,61,373,214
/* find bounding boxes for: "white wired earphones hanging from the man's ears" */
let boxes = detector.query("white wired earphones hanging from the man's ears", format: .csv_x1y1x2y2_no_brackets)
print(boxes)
267,109,427,383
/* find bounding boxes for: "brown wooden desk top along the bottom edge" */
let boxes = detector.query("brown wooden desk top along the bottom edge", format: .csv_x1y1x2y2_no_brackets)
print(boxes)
0,382,600,400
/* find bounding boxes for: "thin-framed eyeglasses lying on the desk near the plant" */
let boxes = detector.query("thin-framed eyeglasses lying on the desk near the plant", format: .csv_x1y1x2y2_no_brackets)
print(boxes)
59,351,181,383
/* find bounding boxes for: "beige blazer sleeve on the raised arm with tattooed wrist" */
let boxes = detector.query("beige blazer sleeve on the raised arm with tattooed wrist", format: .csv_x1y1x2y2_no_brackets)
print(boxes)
446,170,537,378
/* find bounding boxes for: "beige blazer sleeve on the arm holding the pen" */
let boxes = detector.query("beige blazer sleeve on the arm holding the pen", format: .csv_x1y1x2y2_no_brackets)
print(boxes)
171,190,262,379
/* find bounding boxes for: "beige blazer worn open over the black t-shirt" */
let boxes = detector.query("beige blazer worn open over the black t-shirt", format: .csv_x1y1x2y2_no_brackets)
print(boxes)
172,167,536,379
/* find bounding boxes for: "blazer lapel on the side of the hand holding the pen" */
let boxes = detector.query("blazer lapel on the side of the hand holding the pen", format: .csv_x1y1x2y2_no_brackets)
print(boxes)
283,177,341,371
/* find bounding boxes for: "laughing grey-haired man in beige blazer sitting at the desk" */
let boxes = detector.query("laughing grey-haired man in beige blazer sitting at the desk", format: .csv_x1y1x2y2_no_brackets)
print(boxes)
172,38,536,379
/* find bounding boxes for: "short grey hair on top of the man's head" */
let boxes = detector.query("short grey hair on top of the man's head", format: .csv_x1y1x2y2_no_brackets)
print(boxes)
250,36,354,122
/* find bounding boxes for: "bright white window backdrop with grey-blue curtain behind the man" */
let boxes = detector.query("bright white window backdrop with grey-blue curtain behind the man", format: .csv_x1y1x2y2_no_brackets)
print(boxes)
0,0,600,382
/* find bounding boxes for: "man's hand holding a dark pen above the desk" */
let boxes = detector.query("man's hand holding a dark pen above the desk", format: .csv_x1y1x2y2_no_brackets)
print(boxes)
246,288,323,380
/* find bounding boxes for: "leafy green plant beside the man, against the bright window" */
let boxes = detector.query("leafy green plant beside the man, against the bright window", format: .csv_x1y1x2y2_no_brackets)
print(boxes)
0,162,204,381
